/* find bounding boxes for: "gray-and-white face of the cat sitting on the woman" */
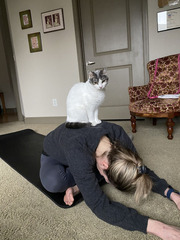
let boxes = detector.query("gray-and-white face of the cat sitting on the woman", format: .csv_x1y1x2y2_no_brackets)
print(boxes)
89,69,109,90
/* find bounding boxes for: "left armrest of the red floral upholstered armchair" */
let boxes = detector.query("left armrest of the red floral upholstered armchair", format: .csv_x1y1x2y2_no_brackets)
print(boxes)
128,85,149,102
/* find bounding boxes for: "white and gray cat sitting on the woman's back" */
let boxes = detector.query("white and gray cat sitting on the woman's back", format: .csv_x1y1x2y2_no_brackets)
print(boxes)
66,69,109,128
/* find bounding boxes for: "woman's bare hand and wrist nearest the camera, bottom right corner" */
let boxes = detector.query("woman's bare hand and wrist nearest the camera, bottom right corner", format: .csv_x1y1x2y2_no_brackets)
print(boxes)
147,219,180,240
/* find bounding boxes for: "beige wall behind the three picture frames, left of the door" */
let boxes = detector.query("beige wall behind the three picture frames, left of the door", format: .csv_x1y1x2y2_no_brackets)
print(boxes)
6,0,79,118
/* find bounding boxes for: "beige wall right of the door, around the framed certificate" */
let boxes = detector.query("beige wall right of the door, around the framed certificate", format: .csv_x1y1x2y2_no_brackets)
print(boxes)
148,0,180,60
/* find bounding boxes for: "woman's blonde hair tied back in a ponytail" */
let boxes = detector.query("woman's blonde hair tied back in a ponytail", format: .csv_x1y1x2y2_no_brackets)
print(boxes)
106,143,152,203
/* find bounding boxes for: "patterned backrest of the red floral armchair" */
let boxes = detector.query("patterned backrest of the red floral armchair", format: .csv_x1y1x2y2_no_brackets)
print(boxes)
147,54,180,98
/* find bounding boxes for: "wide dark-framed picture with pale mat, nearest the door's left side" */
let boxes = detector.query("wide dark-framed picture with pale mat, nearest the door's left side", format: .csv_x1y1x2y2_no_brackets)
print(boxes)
41,8,65,33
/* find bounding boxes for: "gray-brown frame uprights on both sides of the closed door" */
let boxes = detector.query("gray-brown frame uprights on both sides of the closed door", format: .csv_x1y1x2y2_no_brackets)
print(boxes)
72,0,149,84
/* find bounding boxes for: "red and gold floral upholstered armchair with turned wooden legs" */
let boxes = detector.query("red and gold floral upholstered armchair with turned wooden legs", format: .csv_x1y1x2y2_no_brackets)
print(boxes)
128,54,180,139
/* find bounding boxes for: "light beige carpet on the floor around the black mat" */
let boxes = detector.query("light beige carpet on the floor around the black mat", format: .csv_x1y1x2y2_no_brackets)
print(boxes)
0,120,180,240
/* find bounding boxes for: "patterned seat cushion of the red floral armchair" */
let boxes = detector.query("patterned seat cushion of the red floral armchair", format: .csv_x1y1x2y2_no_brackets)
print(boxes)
129,98,180,114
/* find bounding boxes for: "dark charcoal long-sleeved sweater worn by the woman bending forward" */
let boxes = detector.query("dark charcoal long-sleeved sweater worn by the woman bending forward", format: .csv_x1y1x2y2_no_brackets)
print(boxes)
44,122,168,233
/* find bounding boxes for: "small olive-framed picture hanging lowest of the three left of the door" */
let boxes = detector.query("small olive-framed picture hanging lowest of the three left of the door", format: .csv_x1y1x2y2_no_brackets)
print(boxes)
28,32,42,53
